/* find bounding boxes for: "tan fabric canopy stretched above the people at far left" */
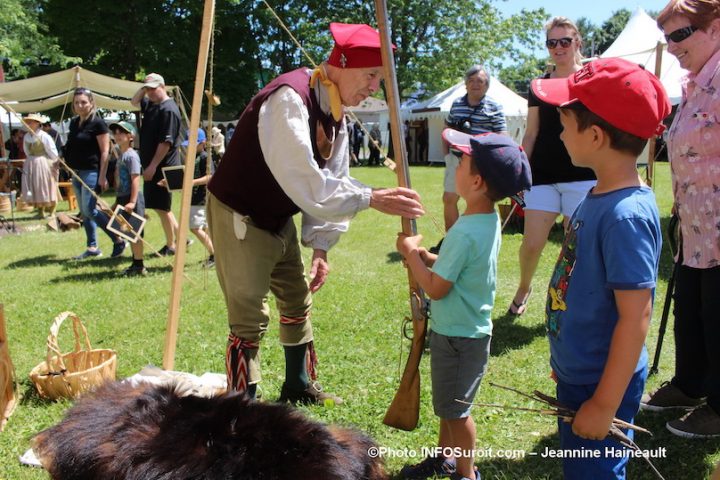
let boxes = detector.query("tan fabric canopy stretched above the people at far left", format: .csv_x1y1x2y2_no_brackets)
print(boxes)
0,66,176,113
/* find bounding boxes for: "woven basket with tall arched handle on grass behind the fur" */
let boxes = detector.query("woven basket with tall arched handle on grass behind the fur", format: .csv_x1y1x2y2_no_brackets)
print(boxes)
30,312,117,400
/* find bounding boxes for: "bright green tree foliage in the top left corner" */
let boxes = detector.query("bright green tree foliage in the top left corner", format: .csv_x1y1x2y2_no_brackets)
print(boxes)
0,0,77,80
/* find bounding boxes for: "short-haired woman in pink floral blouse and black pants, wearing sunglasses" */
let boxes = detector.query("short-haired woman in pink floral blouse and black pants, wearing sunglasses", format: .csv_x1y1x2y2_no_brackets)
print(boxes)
643,0,720,438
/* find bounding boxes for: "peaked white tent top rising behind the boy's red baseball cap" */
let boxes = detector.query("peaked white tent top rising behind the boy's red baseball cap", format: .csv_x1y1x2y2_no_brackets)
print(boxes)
600,7,687,105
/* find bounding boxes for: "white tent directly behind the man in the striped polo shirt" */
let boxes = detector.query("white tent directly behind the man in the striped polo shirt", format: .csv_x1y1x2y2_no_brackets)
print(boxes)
403,77,527,163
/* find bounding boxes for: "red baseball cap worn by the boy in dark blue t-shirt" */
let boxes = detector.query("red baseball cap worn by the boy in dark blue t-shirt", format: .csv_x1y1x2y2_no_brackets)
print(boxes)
531,58,670,138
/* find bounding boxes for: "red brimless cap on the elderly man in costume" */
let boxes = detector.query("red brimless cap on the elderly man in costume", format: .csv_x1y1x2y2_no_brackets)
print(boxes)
328,22,395,68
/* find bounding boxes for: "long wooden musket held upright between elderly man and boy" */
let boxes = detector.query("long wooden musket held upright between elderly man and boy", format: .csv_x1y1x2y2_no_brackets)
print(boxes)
375,0,427,430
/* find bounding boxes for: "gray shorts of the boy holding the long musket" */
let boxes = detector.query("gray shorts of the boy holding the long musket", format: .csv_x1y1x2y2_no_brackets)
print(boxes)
430,330,492,419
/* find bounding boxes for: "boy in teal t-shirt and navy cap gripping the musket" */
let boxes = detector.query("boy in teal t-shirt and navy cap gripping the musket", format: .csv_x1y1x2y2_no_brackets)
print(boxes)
397,129,532,480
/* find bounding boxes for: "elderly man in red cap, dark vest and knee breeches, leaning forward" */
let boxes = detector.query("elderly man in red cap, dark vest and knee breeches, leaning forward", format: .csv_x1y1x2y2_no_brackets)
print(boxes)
208,23,424,404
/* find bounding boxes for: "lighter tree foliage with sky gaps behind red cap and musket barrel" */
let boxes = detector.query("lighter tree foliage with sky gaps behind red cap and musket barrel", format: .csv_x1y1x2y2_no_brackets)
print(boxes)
257,0,546,102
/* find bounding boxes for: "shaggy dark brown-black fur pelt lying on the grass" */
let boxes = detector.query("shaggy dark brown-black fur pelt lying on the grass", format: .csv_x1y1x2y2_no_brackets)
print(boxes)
33,382,387,480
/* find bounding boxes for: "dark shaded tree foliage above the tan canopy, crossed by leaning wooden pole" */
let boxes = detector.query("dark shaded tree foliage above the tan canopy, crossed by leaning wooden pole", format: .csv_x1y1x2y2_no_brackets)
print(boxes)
42,0,259,117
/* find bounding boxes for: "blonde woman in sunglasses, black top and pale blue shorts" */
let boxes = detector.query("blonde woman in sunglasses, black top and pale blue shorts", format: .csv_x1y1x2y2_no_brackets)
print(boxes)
508,17,595,316
